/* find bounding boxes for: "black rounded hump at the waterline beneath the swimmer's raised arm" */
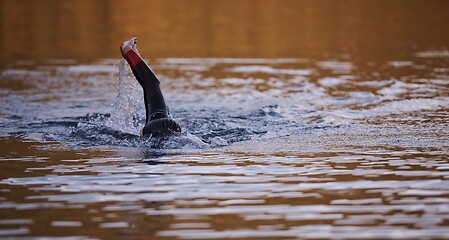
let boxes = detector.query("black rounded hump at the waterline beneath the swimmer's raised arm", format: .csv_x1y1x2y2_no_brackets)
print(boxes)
142,118,181,137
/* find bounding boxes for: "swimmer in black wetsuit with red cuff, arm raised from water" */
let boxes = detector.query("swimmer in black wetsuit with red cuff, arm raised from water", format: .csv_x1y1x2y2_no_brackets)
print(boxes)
120,38,181,137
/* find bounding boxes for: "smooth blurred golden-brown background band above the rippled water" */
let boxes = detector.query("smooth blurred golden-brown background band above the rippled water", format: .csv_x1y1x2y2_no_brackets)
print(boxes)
0,0,449,61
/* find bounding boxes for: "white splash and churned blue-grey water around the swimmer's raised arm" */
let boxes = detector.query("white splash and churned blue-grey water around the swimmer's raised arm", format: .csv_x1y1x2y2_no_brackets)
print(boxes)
59,59,262,149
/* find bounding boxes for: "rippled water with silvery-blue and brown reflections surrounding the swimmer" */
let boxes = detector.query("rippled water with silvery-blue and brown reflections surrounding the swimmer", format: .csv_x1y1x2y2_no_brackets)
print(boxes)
0,52,449,239
